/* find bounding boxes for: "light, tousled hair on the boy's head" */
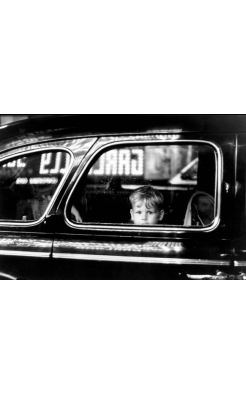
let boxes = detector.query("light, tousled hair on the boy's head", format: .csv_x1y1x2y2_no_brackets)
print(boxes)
129,185,164,210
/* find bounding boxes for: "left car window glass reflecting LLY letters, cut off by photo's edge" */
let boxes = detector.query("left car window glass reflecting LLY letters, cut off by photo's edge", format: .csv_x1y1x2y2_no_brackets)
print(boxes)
0,151,70,221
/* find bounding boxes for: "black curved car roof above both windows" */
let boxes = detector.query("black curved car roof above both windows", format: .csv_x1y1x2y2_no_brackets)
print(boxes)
0,114,246,149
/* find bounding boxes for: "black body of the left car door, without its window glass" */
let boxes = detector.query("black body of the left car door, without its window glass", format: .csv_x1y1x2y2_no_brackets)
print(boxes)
0,138,96,279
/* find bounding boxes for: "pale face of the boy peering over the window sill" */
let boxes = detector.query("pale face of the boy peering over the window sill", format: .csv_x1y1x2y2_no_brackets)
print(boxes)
131,201,164,225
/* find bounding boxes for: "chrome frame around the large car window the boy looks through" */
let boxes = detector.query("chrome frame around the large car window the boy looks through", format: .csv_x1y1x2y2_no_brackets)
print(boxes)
64,137,223,234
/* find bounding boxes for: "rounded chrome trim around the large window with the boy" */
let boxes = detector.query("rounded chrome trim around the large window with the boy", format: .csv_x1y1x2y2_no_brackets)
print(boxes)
64,138,222,234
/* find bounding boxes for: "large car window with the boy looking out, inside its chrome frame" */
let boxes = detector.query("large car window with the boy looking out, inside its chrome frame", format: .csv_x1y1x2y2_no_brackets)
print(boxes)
67,143,217,228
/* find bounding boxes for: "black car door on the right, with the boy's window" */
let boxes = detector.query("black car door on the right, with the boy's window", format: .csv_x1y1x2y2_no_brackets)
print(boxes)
52,128,235,279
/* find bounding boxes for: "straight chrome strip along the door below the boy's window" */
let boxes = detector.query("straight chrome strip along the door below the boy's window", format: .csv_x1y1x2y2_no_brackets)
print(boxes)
53,252,230,266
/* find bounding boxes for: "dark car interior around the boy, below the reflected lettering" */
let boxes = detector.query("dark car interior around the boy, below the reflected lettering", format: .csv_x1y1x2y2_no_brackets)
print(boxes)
69,147,216,227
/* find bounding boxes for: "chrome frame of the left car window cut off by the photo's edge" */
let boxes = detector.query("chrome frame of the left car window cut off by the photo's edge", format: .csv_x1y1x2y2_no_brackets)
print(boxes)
0,143,75,228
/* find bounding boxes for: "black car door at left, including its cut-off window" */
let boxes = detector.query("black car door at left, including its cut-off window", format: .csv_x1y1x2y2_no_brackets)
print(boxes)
0,138,95,279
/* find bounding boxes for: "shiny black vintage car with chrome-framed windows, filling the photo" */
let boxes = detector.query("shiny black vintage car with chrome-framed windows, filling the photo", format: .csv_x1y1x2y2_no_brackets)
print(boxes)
0,115,246,279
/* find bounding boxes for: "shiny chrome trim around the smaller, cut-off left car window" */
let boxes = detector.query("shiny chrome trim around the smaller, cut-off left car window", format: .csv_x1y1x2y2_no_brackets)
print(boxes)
0,146,74,228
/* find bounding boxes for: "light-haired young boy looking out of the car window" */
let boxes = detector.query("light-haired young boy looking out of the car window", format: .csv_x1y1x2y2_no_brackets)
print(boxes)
129,186,164,225
